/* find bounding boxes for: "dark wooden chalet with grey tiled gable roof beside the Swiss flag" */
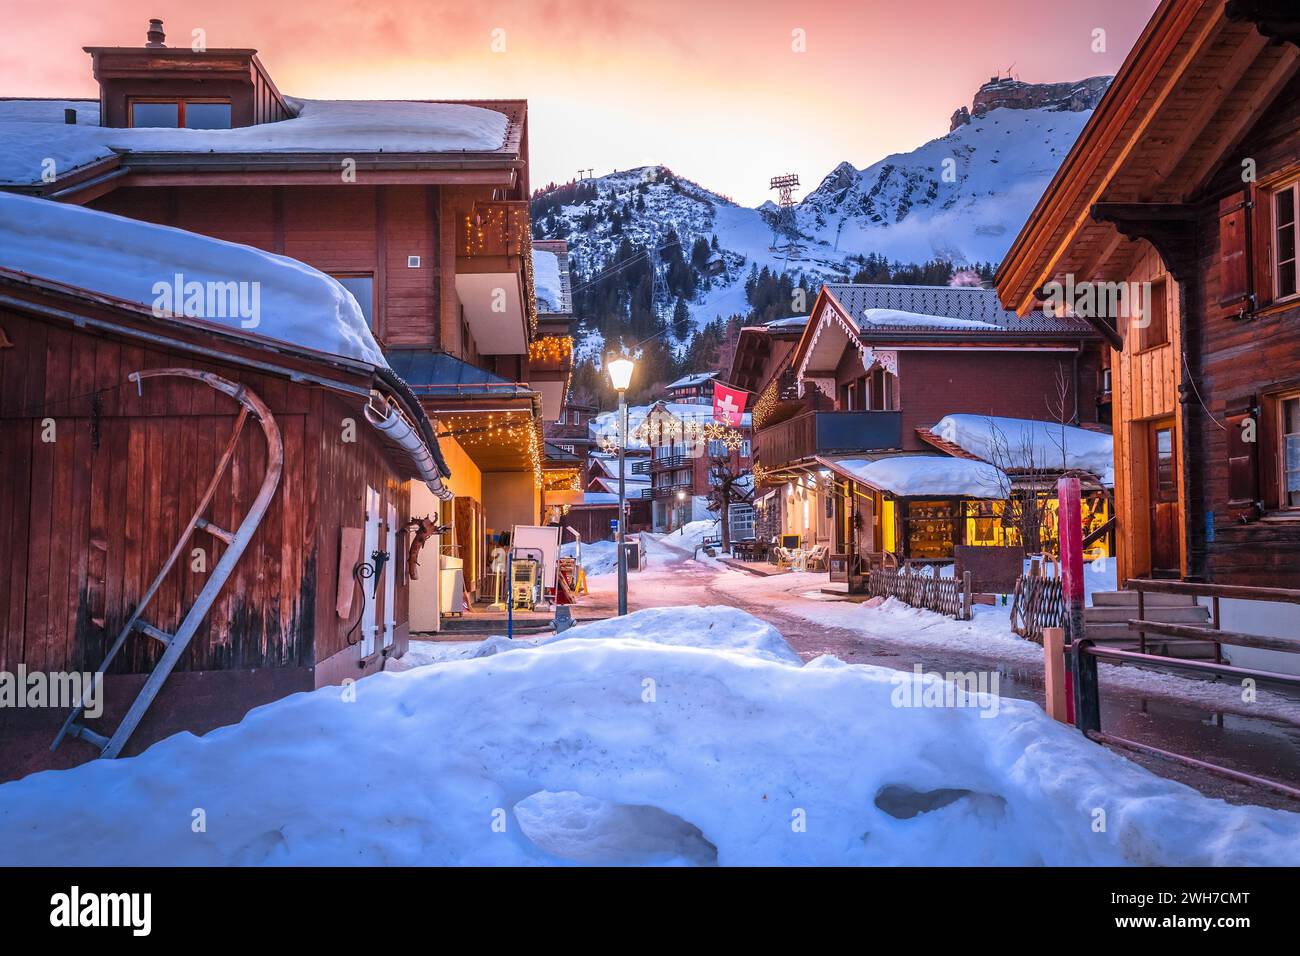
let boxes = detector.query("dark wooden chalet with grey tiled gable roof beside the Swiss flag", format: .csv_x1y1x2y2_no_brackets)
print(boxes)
731,285,1105,568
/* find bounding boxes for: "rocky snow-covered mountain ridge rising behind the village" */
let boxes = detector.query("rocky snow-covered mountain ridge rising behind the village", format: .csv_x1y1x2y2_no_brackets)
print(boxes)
534,77,1110,330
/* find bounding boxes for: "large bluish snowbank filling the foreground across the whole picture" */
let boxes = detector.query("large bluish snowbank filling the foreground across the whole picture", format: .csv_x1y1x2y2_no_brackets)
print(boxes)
0,609,1300,866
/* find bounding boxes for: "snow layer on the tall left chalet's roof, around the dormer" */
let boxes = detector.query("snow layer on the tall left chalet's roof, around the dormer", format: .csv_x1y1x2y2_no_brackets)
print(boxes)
0,98,506,185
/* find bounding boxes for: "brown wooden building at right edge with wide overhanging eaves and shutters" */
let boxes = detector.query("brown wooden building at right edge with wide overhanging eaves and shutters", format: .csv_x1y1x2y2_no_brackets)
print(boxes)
998,0,1300,590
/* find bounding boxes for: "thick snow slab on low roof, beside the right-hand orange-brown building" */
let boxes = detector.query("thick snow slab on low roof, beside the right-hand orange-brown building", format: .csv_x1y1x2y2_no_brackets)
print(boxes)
931,415,1115,485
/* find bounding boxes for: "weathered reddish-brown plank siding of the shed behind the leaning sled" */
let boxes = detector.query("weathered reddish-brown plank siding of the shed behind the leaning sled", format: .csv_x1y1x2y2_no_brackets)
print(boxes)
0,299,410,779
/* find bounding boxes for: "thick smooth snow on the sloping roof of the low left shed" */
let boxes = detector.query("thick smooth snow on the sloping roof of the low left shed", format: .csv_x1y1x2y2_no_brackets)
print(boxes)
0,193,387,367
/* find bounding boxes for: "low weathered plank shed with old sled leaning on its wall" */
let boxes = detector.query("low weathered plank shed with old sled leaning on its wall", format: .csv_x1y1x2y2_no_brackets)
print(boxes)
0,248,450,779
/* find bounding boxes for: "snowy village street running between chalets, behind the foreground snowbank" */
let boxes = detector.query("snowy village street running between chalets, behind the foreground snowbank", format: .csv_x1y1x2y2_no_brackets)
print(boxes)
569,522,1300,810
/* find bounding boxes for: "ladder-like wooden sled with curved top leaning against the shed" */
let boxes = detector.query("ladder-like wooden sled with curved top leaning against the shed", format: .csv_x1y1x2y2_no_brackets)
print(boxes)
49,368,285,757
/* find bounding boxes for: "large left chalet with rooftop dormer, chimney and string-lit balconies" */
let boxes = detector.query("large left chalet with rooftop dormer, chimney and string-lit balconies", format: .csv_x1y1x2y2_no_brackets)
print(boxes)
0,21,572,631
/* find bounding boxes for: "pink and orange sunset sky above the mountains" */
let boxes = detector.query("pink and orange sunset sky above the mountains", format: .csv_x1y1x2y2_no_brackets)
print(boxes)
0,0,1157,204
